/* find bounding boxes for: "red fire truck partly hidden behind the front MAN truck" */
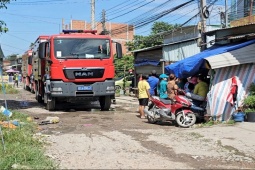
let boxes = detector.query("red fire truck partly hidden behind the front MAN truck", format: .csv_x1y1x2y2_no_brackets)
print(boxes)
22,35,49,93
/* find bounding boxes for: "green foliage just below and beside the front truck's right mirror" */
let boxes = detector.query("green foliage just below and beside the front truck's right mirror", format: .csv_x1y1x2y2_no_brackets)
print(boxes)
114,55,134,78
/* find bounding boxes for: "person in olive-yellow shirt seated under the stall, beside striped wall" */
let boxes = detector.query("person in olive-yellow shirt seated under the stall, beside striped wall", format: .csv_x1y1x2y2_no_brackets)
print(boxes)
186,75,209,106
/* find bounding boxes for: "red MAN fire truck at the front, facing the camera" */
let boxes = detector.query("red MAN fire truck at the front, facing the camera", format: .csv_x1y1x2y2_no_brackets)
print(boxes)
33,30,122,110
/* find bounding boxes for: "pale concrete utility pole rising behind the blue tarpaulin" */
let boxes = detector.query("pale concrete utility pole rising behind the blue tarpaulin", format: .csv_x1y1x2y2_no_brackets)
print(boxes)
200,0,207,51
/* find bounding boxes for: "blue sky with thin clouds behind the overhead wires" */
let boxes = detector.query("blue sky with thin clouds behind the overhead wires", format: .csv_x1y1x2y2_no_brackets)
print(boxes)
0,0,226,56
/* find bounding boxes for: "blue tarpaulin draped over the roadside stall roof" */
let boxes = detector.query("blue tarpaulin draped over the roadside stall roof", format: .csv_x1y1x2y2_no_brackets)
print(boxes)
165,40,255,78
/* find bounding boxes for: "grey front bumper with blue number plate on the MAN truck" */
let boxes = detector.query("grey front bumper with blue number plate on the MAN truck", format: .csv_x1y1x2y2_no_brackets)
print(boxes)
47,80,115,97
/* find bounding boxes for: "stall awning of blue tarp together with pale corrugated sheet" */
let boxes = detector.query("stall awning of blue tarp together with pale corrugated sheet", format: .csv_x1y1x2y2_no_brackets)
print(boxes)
165,40,255,78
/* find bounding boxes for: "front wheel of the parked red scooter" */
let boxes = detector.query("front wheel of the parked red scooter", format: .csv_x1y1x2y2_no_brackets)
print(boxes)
176,112,196,128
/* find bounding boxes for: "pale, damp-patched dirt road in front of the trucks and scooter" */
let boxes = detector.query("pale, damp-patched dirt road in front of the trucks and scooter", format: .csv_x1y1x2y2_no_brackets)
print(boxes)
1,90,255,169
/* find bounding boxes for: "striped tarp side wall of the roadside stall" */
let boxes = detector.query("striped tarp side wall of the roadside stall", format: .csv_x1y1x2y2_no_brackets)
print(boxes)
207,64,255,121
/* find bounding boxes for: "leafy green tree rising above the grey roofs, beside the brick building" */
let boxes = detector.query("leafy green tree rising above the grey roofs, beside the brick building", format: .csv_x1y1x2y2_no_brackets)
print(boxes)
126,22,179,51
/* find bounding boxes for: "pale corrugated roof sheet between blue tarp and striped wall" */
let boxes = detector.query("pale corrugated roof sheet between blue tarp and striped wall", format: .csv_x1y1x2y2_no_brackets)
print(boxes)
205,44,255,69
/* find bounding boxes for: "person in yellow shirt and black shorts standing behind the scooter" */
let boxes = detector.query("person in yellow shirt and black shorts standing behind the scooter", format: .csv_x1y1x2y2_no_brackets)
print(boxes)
138,75,150,119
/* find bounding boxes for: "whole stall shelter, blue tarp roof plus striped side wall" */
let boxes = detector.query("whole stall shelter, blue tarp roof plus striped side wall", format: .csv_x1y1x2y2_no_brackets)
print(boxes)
165,40,255,121
